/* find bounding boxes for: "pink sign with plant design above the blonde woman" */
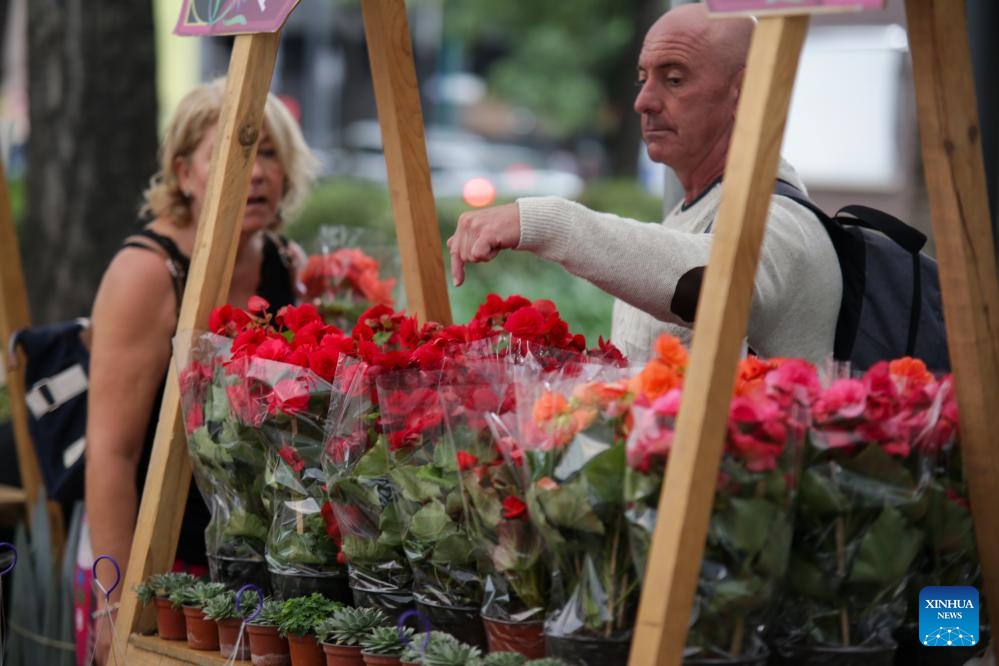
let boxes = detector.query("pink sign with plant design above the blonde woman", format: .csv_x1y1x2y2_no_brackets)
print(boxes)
174,0,298,37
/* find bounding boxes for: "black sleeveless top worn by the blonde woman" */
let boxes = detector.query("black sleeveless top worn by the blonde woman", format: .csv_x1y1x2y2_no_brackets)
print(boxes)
124,229,295,566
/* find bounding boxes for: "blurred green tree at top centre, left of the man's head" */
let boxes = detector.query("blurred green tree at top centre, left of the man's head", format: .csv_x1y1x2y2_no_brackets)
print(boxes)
444,0,667,175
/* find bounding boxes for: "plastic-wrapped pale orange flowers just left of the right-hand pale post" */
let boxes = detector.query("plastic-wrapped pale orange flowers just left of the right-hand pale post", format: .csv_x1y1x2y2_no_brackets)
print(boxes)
507,366,638,644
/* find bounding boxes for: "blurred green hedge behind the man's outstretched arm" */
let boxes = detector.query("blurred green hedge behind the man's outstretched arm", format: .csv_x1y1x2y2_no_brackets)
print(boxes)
286,179,662,346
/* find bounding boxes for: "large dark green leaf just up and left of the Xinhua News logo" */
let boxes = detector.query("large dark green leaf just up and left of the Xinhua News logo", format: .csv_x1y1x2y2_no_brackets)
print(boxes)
849,506,923,588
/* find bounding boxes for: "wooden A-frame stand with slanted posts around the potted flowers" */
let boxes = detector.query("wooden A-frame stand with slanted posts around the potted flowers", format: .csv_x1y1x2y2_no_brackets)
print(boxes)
0,0,984,666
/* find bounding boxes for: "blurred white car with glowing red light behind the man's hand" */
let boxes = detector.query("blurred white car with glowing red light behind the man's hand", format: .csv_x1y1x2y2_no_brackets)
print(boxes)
330,120,584,206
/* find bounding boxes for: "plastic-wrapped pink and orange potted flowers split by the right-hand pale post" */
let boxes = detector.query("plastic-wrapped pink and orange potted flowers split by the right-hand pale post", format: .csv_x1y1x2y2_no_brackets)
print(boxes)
625,348,819,663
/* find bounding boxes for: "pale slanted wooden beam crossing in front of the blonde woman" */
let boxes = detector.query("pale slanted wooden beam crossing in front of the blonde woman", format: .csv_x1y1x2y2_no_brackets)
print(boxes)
115,33,280,649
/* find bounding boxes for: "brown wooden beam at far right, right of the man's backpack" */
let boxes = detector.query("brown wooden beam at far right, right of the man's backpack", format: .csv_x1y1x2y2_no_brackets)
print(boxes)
906,0,999,658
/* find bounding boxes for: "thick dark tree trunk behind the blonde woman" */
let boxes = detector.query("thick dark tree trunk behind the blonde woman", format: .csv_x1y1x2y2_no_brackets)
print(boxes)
21,0,157,323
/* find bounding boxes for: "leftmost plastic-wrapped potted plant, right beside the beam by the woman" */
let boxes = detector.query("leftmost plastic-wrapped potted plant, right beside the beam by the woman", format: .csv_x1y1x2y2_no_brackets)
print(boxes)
174,333,269,568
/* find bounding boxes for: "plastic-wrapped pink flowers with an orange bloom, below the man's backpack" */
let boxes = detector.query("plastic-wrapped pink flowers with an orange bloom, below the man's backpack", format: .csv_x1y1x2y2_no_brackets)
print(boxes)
777,358,960,654
